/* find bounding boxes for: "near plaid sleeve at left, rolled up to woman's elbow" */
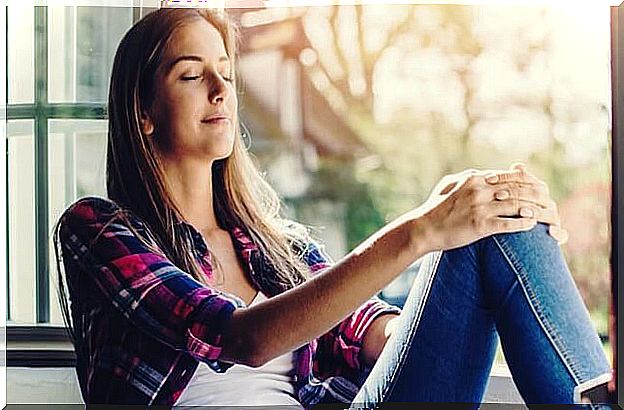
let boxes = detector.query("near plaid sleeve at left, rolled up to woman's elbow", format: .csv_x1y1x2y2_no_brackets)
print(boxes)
59,197,244,372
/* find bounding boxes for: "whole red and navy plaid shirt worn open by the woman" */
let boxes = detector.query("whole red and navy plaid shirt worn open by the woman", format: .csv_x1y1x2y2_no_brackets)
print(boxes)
59,197,400,407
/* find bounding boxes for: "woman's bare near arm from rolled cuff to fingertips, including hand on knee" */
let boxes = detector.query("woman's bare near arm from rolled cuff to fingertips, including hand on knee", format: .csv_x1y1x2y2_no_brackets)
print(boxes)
220,171,544,366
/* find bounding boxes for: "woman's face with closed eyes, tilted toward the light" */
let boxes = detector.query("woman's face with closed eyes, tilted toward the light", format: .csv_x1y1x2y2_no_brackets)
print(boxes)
142,19,237,161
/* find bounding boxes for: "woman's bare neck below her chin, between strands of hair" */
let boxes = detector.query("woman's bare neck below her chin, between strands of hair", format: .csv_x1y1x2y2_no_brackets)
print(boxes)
164,155,219,233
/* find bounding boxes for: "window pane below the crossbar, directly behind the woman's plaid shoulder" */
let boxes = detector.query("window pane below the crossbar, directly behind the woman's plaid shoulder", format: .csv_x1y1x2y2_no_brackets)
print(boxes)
48,120,107,324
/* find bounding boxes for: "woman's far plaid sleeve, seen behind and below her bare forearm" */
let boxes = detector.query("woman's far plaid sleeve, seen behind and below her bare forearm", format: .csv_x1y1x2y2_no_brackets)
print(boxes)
304,243,401,378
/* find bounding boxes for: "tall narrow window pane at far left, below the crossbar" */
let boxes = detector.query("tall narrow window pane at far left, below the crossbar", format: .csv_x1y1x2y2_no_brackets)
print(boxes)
7,120,35,323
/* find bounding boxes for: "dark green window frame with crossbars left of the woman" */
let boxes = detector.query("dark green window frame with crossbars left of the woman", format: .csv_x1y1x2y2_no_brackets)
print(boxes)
3,5,146,346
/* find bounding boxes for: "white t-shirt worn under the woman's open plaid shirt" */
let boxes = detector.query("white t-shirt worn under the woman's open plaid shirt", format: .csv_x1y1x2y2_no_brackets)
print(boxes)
175,292,303,409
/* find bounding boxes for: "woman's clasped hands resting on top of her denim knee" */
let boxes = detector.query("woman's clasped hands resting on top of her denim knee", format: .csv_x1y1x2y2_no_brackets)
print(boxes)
419,165,567,250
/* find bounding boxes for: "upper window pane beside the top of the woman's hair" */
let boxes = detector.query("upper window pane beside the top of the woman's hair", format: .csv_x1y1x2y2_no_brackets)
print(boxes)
48,6,132,102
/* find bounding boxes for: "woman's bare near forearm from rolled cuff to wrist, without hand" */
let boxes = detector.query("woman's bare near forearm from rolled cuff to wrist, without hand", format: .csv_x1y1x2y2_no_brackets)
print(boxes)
220,217,428,366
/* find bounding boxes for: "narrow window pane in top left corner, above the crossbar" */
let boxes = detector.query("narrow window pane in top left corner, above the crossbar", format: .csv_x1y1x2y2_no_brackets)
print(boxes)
7,3,35,104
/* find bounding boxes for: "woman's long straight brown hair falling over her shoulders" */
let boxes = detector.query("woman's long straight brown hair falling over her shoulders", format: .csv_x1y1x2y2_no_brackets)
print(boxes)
55,8,309,342
